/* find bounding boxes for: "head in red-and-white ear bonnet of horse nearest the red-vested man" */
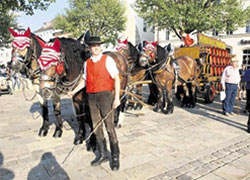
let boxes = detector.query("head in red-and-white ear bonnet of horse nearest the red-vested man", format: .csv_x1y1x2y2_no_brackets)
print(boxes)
38,38,64,99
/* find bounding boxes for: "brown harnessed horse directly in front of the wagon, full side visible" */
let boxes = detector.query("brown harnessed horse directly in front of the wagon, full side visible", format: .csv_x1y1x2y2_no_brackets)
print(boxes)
140,42,200,114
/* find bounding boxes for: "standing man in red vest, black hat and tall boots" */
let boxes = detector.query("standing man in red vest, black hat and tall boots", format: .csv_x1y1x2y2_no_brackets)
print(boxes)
67,37,120,171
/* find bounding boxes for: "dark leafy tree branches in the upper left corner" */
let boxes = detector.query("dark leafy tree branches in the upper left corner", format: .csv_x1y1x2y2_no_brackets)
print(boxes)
0,0,56,47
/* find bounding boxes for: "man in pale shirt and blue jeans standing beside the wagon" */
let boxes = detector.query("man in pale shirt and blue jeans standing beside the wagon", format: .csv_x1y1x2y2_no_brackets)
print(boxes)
221,57,240,116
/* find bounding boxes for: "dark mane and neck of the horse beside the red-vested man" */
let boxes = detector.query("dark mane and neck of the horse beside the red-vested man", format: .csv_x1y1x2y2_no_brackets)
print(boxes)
50,37,87,82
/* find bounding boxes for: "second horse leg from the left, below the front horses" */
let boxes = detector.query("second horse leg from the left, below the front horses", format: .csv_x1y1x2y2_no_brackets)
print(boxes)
52,94,63,138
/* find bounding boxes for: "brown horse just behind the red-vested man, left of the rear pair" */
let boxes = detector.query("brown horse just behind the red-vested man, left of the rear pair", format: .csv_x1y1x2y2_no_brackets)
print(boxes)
116,40,158,110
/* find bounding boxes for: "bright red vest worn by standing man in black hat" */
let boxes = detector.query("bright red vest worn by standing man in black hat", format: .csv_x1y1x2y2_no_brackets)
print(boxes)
86,55,114,93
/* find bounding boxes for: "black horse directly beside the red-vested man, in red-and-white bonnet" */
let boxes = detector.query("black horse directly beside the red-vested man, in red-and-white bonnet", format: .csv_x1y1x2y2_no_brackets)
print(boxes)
38,36,96,148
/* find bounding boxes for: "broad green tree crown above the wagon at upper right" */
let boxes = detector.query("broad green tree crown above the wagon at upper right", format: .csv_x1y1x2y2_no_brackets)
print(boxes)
134,0,249,38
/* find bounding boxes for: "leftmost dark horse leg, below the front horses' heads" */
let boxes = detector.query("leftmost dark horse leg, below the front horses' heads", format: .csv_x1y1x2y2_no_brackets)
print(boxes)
38,100,49,137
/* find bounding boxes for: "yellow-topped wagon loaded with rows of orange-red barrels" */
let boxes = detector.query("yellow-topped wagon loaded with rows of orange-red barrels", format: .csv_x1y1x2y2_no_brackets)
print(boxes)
174,34,233,103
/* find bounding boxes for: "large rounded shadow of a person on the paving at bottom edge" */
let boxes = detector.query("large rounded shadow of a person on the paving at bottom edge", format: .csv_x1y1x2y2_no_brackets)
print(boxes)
28,152,70,180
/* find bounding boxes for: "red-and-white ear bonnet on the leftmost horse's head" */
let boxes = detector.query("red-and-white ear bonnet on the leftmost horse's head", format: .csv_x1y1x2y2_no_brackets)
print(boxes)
9,27,31,50
